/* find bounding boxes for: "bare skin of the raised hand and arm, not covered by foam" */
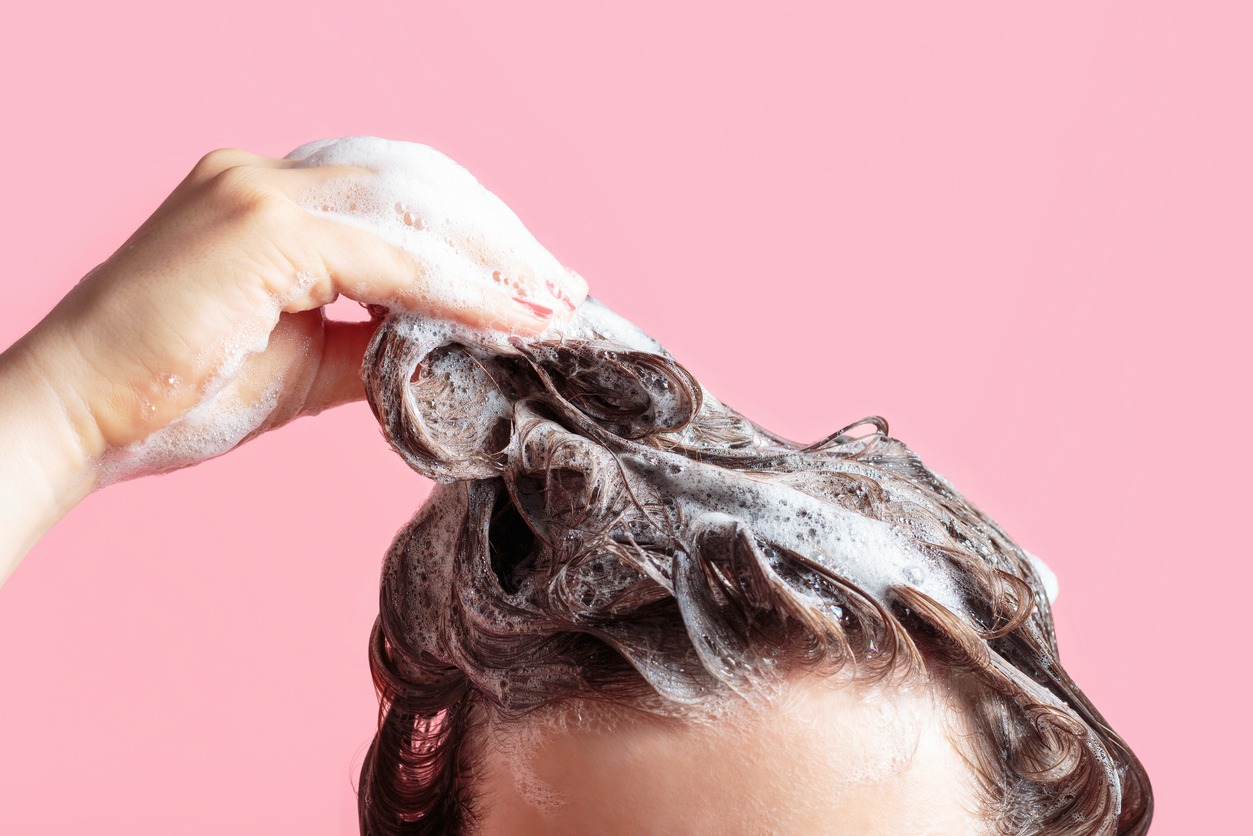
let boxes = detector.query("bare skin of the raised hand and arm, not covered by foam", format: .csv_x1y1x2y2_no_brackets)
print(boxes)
0,149,586,583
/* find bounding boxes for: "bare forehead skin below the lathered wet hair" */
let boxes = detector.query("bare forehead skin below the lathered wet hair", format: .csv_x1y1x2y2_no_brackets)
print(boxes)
472,676,989,836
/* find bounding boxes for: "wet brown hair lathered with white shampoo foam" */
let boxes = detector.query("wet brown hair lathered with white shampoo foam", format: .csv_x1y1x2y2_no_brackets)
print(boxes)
358,301,1153,836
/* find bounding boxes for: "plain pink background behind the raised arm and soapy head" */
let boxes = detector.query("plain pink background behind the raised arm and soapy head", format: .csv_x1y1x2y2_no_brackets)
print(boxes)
0,0,1253,835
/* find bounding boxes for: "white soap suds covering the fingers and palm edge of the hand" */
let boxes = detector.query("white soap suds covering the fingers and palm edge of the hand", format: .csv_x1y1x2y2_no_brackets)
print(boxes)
98,137,586,485
